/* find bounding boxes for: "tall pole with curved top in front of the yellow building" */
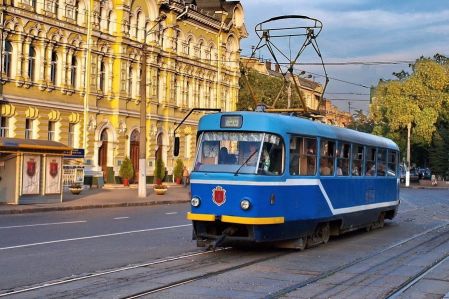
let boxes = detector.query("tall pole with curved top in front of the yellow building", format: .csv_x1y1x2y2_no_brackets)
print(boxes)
138,14,167,197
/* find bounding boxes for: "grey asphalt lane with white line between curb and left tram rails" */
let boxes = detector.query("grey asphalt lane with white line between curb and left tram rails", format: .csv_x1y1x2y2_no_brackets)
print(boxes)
0,204,197,290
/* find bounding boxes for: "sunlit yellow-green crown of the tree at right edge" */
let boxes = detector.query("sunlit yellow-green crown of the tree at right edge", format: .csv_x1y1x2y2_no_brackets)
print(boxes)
371,58,449,144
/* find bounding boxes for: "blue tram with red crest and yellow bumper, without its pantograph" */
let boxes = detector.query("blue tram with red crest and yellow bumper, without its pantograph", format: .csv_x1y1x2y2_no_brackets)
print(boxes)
187,112,399,249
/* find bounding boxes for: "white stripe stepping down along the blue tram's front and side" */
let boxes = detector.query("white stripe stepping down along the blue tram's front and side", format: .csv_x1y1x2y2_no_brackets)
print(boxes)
190,179,399,215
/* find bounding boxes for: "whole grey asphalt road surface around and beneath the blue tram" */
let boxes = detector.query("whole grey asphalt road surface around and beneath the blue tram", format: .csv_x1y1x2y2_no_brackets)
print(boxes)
0,189,449,298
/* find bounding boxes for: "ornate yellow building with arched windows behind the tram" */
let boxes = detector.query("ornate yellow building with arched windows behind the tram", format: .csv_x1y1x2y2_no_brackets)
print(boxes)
0,0,247,183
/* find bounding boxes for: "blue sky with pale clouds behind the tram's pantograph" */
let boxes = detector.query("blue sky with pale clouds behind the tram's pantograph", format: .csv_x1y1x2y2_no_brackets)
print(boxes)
240,0,449,113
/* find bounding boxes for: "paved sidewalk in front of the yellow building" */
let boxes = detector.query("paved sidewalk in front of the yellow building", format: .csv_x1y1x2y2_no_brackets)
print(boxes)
0,183,190,214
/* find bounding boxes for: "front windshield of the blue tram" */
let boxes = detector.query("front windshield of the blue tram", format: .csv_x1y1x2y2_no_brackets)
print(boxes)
194,131,284,175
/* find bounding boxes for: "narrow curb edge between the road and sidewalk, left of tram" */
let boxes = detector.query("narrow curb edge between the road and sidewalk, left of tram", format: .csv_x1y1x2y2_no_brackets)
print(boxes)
0,200,189,215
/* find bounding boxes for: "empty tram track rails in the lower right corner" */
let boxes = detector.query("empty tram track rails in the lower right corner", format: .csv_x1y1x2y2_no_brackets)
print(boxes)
264,224,449,299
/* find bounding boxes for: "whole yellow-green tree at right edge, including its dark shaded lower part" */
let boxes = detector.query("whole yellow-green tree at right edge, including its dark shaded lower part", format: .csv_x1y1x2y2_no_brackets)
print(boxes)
370,54,449,173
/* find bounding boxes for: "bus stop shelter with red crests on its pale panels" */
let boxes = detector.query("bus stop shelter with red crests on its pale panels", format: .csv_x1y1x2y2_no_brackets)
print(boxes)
0,138,72,204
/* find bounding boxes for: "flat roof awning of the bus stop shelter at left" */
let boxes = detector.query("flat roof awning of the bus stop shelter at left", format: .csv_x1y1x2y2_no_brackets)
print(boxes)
0,138,73,155
